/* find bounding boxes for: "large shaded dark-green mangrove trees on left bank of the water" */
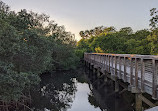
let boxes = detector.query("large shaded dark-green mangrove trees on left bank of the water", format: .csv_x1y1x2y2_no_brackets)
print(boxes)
0,1,78,106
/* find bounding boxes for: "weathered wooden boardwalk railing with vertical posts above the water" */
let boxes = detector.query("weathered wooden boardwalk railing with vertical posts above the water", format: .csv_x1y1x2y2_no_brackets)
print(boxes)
84,53,158,99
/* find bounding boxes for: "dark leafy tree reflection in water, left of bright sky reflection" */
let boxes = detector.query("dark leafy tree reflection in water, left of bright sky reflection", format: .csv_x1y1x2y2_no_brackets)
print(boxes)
32,72,77,111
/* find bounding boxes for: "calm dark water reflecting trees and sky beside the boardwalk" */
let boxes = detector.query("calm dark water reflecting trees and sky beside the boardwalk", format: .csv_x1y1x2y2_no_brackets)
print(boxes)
31,69,133,111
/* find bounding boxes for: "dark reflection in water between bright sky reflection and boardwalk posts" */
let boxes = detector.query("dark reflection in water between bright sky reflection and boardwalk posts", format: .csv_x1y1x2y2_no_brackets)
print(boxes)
86,70,134,111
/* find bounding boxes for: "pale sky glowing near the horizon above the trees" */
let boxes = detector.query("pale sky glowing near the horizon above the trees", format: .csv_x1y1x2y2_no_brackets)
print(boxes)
2,0,158,40
